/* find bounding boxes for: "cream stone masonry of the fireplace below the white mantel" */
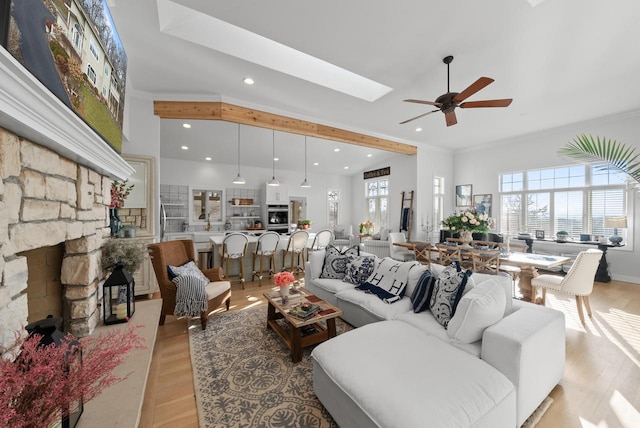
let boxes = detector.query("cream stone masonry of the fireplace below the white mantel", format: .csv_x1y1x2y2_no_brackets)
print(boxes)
0,128,111,340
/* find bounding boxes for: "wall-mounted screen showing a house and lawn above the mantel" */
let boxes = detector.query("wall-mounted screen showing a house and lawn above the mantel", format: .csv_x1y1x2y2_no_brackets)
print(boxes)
7,0,127,152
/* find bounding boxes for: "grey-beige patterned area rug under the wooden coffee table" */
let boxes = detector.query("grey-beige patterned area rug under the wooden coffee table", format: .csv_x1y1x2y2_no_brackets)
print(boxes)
189,305,553,428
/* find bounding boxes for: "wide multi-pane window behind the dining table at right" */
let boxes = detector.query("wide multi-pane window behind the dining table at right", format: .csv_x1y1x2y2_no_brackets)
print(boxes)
500,164,627,239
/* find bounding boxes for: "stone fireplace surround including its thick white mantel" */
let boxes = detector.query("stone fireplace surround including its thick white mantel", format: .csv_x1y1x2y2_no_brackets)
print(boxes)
0,47,133,349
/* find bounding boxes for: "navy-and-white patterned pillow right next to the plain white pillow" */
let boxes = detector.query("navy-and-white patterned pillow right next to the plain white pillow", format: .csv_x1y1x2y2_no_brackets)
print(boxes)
429,261,472,328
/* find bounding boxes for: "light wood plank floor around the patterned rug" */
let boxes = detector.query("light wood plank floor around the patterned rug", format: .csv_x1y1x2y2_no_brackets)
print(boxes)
140,274,640,428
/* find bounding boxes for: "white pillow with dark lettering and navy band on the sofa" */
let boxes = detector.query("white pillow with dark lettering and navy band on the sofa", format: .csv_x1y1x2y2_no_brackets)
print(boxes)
356,257,418,303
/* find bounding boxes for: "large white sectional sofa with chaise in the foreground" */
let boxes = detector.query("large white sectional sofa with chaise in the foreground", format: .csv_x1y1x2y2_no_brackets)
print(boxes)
305,250,565,428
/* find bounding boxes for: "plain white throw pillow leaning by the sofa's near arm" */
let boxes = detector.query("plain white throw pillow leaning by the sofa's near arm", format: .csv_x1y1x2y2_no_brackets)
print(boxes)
447,280,507,343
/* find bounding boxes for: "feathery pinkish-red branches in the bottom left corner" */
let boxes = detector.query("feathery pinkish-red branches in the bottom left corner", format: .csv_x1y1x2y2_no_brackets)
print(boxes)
0,325,145,428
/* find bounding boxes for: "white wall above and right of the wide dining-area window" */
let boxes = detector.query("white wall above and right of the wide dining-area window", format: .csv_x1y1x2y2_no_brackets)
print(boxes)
454,112,640,282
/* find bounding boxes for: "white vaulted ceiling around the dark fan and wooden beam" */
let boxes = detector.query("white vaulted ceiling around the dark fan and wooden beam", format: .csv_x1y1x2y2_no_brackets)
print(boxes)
109,0,640,174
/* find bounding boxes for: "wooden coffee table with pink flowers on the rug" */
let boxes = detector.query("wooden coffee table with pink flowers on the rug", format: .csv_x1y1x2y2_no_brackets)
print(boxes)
264,289,342,363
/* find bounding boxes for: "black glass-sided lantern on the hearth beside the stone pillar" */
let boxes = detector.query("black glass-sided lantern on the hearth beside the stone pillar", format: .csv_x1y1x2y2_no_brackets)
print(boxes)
102,263,136,325
